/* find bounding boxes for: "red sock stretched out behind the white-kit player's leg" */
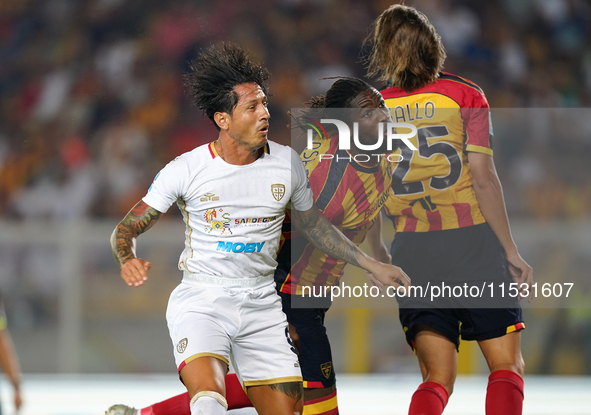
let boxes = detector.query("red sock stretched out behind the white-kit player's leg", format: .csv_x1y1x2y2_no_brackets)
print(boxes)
140,373,252,415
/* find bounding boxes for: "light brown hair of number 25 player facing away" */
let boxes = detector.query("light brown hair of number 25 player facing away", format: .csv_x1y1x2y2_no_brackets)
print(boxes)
366,4,446,92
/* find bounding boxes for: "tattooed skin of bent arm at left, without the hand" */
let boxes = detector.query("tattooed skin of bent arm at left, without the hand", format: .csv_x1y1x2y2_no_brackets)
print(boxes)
111,201,162,266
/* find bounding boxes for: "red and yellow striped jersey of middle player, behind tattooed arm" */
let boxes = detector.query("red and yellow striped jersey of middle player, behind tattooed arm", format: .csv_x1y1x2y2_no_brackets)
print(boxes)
276,136,392,294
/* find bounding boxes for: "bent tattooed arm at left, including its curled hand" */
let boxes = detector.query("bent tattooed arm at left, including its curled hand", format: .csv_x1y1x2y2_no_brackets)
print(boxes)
111,201,162,287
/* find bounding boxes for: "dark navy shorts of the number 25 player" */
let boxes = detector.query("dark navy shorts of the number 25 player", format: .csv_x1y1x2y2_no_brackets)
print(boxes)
391,223,525,347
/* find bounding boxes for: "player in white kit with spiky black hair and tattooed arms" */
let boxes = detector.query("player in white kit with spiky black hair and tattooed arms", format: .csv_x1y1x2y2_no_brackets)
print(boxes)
111,44,410,415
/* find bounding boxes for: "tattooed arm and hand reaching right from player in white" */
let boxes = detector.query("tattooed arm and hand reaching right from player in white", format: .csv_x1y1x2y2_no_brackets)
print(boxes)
291,204,410,287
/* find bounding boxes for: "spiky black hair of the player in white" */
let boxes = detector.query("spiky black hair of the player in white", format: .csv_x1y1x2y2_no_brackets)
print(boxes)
183,42,269,130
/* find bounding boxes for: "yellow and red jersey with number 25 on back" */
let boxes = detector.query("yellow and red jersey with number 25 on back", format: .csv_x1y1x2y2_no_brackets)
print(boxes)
382,72,493,232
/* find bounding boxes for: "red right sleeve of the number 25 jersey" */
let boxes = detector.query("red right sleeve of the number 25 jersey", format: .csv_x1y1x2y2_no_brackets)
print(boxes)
462,92,493,156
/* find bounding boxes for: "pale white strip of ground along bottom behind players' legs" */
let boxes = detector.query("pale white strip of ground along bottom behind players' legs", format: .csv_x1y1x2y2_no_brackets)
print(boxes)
0,374,591,415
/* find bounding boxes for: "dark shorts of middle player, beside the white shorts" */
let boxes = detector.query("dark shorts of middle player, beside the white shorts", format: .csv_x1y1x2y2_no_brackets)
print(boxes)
279,292,335,388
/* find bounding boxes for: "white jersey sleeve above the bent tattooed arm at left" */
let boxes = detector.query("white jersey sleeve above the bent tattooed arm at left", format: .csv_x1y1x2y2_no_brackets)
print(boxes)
142,158,188,213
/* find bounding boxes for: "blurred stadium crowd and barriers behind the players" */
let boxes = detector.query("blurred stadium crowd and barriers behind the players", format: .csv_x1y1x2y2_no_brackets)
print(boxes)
0,0,591,400
